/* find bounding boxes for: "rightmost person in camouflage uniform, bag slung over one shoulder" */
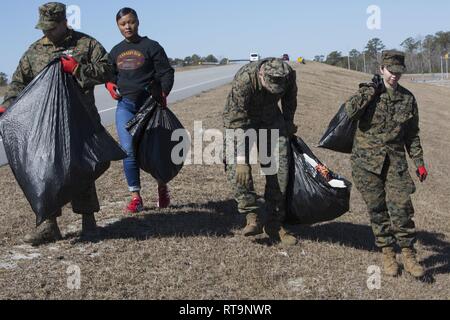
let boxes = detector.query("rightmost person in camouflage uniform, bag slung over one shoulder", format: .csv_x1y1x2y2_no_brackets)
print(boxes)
346,51,427,277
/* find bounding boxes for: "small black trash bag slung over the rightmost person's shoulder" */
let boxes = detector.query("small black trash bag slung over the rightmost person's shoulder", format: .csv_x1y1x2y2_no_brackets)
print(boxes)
319,104,358,153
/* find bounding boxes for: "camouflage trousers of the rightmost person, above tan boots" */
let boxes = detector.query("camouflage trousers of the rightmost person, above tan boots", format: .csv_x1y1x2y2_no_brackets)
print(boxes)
352,157,416,248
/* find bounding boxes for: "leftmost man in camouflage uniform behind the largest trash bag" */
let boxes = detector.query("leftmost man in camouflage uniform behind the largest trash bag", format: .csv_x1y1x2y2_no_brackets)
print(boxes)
0,2,112,245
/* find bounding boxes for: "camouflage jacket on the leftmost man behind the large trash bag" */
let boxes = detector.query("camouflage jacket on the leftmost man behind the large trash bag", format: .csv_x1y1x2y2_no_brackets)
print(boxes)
3,29,112,122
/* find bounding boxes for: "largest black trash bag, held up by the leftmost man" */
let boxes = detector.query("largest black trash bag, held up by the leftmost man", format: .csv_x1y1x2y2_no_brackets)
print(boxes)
0,60,126,225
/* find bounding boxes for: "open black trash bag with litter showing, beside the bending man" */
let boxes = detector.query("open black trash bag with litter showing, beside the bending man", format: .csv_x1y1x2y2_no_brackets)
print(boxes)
286,137,352,225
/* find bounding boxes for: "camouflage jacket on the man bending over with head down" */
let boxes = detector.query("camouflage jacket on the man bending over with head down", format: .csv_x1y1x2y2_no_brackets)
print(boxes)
223,60,298,130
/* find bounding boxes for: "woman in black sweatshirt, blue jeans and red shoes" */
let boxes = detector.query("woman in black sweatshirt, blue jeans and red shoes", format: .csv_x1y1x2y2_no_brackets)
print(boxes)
106,8,174,213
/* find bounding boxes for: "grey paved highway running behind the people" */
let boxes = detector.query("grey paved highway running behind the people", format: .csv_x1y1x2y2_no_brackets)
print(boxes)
0,64,242,166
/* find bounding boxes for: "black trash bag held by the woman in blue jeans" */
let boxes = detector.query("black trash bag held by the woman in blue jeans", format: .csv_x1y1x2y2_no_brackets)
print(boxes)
127,97,190,184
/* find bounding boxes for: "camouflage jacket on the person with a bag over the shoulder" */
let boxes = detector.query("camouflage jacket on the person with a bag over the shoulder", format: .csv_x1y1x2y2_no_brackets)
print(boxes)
346,84,424,174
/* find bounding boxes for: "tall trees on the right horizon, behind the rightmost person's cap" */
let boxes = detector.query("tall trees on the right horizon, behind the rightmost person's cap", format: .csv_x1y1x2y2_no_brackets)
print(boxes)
314,31,450,73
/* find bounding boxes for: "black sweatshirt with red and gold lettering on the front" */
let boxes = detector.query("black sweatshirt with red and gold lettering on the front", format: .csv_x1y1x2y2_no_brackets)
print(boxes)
110,37,175,102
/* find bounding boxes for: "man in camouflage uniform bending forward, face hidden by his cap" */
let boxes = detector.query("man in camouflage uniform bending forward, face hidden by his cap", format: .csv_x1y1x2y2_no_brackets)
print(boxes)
223,58,297,245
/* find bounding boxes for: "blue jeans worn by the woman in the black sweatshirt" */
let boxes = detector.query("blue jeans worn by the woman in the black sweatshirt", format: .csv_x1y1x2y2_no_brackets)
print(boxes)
116,98,141,192
